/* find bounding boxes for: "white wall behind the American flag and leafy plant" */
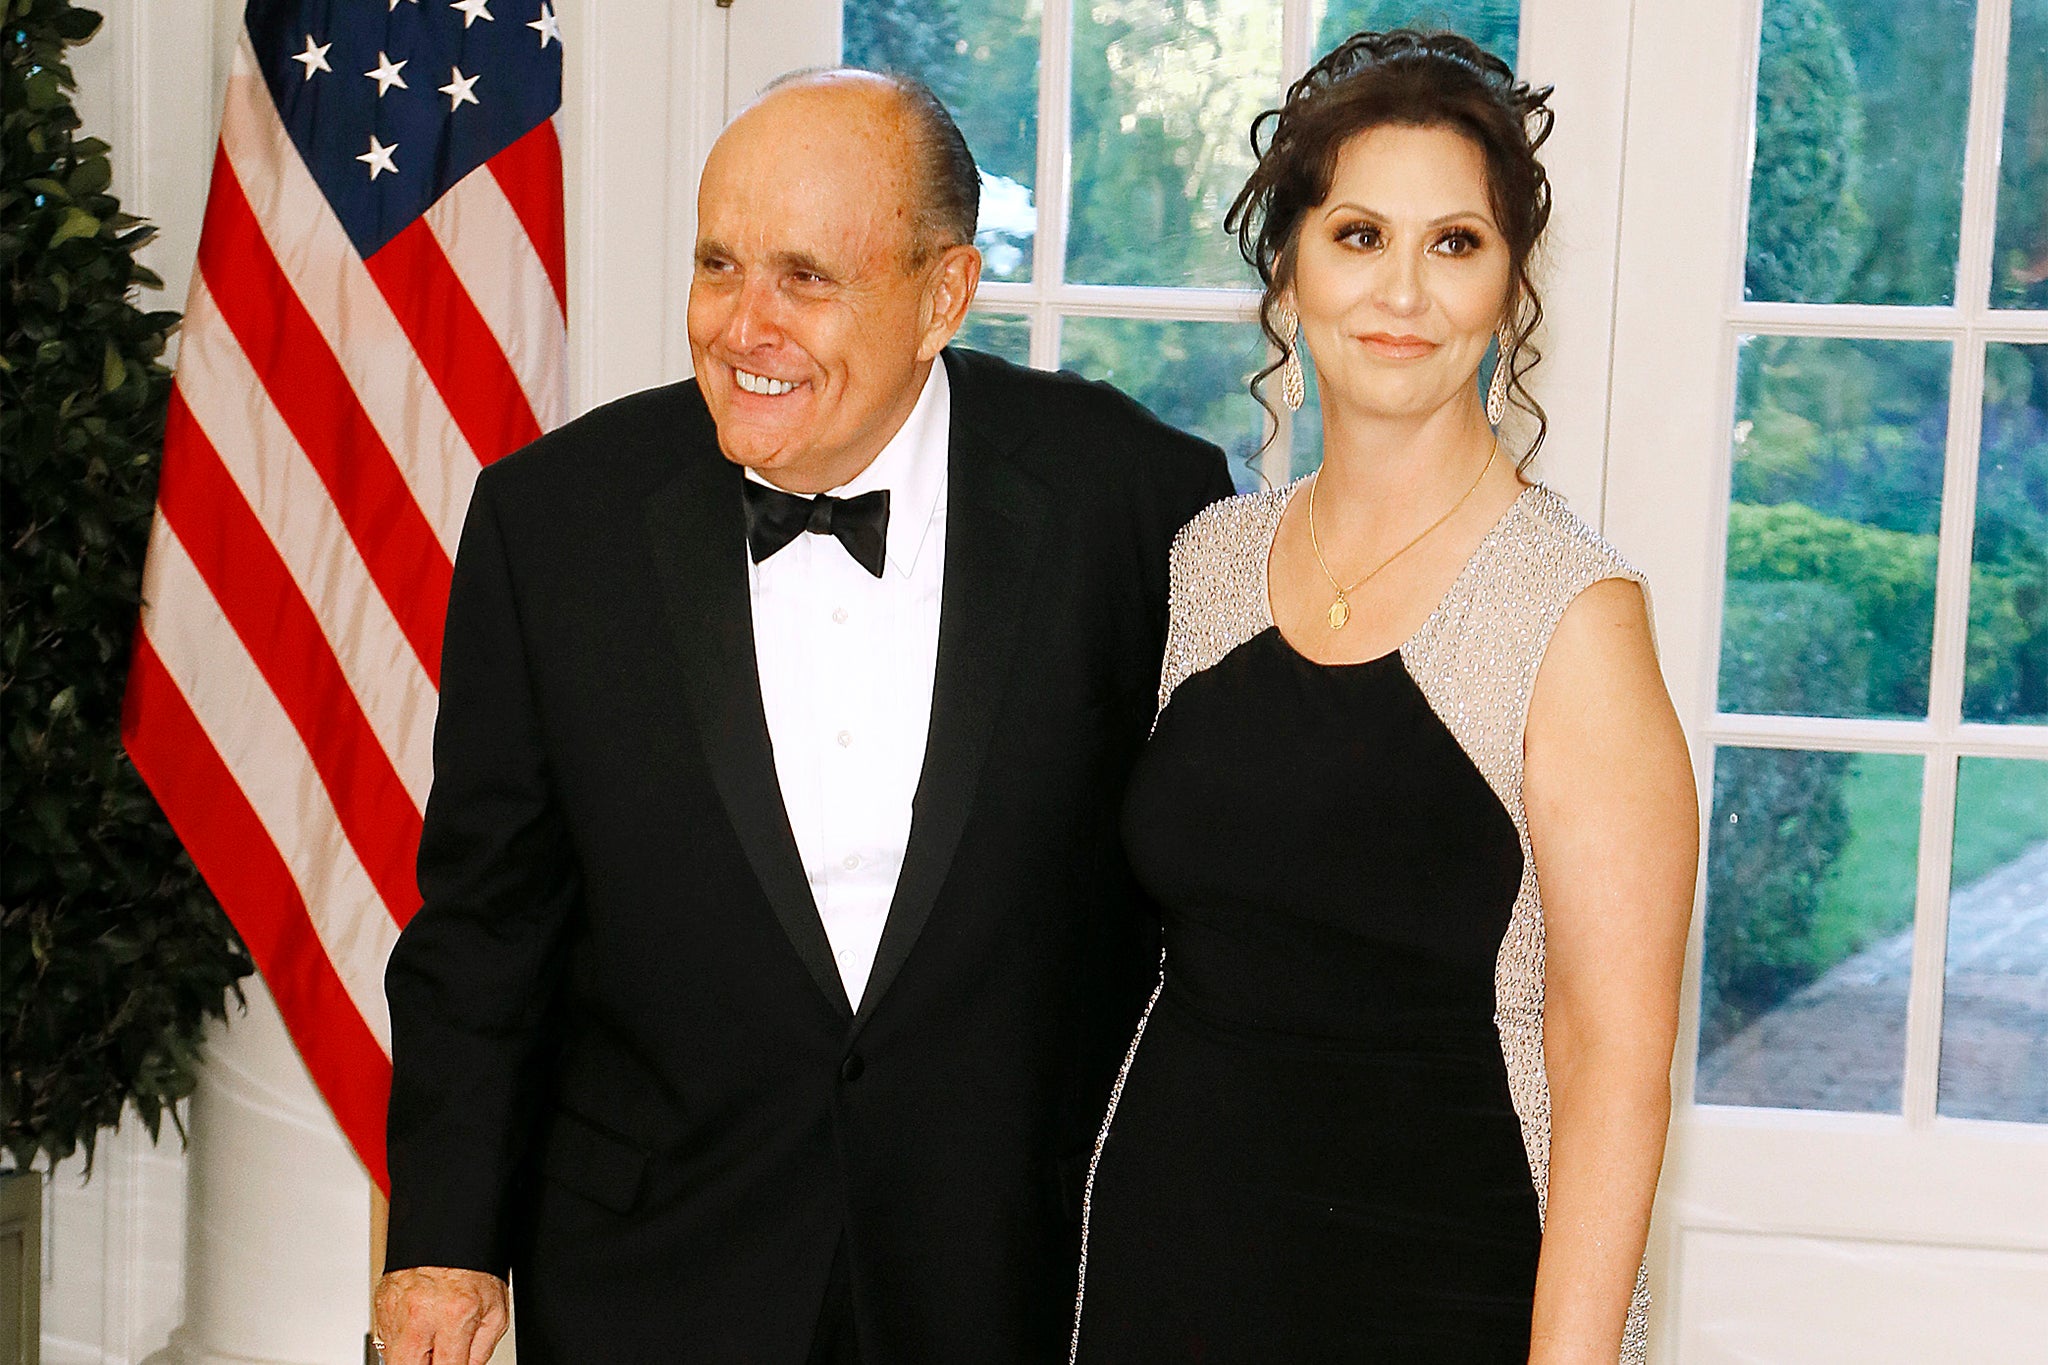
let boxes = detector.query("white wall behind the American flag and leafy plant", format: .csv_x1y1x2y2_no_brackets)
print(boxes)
43,0,737,1365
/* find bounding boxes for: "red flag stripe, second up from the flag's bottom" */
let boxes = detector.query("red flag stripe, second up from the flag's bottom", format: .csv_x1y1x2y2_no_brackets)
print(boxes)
156,387,420,925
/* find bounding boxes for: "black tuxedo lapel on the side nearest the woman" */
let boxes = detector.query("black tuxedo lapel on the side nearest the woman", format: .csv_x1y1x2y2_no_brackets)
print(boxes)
854,354,1053,1029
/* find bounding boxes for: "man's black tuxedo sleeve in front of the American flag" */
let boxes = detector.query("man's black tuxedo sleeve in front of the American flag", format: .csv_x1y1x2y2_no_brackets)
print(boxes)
385,471,580,1275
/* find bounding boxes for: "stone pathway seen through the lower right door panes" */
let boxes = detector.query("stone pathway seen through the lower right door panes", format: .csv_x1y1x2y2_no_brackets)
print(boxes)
1696,841,2048,1124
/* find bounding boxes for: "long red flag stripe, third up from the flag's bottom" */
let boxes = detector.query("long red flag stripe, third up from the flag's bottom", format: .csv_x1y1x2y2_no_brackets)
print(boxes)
199,147,450,686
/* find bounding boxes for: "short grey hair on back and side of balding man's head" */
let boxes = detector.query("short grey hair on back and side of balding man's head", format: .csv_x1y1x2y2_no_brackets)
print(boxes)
757,65,981,268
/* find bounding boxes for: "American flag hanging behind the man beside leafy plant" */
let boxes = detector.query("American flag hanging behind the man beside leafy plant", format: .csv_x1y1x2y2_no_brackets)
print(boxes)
123,0,567,1187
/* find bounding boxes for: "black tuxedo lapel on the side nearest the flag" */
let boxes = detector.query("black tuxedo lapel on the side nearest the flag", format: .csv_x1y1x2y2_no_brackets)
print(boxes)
645,444,854,1019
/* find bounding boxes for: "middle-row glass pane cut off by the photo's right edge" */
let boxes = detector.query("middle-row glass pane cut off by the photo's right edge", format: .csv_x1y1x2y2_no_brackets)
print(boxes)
1962,343,2048,724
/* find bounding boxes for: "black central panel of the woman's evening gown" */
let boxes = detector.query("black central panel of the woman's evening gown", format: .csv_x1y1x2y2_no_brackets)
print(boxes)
1077,626,1542,1365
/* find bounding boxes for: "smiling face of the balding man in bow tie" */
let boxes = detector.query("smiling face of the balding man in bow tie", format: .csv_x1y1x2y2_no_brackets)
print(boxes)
688,78,950,493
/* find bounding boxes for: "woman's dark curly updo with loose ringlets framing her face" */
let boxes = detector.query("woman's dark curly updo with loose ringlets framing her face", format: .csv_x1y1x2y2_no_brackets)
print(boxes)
1223,29,1554,465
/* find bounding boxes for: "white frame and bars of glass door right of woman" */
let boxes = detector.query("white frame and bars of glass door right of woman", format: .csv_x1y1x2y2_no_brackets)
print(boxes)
1606,0,2048,1365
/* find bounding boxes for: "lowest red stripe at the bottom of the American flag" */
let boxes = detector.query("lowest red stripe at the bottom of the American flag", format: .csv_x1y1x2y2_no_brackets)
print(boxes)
121,630,391,1189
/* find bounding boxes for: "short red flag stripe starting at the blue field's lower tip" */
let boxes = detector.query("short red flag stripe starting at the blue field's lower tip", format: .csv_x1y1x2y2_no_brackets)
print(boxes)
362,217,541,465
